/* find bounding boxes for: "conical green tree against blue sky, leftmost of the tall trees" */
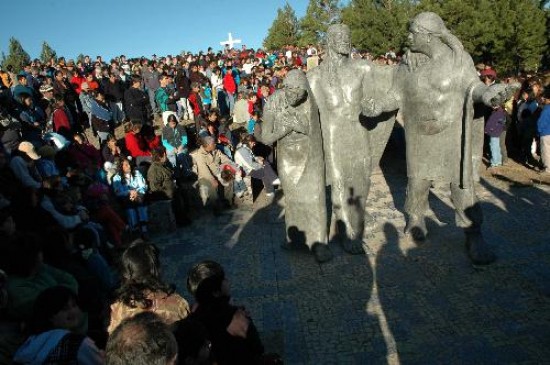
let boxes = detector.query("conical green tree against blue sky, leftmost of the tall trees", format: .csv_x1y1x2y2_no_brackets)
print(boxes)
264,2,299,50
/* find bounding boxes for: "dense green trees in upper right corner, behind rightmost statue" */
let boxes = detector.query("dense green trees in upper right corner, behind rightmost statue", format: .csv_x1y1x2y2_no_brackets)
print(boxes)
418,0,548,74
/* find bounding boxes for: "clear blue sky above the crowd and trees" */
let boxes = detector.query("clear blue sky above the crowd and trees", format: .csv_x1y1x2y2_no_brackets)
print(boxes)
0,0,308,59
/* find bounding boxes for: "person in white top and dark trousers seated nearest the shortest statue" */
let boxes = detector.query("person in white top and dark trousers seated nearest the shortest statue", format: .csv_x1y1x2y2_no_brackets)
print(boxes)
235,134,281,197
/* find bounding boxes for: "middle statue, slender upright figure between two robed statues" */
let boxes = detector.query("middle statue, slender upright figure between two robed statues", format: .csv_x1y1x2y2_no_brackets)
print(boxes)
307,24,393,254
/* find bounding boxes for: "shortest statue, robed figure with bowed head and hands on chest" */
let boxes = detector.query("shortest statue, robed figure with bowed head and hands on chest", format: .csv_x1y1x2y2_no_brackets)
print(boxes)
260,70,333,262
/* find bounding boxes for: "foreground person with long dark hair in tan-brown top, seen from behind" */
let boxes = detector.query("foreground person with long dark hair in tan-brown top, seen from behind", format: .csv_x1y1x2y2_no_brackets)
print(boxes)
108,240,189,336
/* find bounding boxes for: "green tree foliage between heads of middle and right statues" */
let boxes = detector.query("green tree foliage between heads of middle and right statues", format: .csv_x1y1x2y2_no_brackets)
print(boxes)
342,0,415,55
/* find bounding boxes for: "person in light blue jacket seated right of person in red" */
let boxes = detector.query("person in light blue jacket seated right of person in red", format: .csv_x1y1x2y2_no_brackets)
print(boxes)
162,114,191,175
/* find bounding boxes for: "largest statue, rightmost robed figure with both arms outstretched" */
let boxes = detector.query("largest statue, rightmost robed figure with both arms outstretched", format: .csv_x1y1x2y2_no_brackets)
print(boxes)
363,12,513,265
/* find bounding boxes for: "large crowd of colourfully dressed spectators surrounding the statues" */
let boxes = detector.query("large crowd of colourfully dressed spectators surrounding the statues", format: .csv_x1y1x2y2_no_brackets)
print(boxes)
0,41,550,364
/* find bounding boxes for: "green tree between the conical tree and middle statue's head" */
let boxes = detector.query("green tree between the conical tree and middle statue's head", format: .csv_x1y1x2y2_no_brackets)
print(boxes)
298,0,340,46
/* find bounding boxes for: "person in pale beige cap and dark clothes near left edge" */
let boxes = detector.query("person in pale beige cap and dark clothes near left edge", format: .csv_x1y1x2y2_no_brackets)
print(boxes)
10,141,42,189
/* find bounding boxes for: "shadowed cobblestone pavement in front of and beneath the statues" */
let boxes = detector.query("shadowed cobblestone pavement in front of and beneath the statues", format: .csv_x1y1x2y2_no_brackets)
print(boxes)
156,152,550,364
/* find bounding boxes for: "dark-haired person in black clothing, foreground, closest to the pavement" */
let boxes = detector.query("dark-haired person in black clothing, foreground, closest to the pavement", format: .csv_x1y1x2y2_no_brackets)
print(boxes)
187,261,264,365
